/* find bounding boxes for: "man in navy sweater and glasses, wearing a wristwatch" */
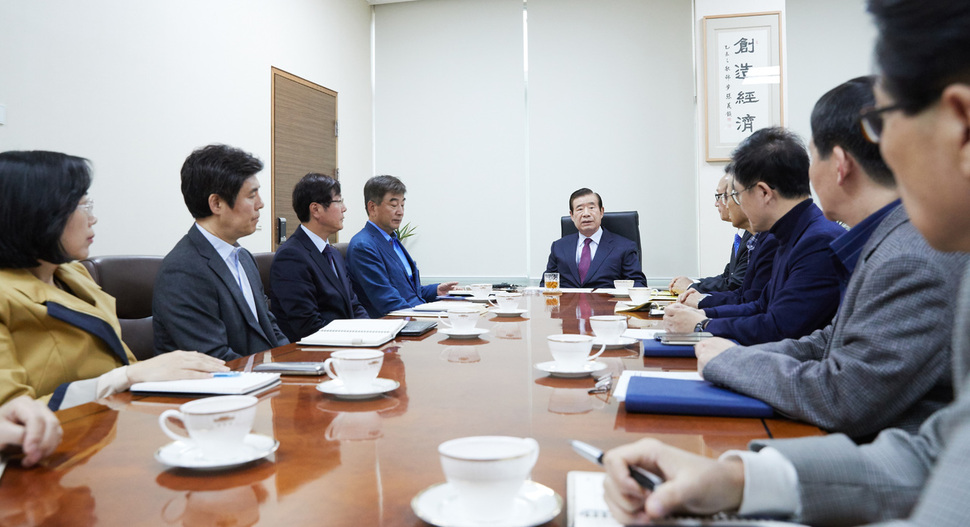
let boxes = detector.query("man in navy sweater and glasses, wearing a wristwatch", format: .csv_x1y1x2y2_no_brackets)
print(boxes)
664,128,845,345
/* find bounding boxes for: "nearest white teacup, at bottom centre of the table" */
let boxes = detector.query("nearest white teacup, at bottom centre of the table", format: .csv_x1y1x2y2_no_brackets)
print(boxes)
438,436,539,522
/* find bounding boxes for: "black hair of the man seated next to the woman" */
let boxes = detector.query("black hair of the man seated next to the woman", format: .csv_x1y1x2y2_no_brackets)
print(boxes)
182,145,263,219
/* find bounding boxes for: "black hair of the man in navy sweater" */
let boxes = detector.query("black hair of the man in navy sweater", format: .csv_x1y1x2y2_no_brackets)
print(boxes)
731,126,811,199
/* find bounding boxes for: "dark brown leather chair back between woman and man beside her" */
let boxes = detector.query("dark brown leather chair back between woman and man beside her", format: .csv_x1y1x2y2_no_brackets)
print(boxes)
81,256,162,360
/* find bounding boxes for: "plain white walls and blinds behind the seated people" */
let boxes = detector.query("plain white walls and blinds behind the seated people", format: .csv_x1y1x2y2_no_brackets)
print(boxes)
0,0,875,279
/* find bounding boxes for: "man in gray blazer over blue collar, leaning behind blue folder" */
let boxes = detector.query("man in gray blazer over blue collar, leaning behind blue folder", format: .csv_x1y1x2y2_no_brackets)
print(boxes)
695,77,967,440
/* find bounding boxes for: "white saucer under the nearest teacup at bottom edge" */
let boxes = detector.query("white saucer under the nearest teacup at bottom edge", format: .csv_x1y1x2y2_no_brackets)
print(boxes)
411,481,562,527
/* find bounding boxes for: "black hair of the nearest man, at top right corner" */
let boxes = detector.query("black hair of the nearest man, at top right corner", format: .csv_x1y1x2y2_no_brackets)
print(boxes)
869,0,970,115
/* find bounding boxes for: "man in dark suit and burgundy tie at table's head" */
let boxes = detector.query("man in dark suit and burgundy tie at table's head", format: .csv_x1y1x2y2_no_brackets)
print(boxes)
546,188,647,287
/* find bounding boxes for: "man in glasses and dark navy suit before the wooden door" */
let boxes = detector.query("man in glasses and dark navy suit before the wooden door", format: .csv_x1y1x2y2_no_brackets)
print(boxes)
269,173,368,342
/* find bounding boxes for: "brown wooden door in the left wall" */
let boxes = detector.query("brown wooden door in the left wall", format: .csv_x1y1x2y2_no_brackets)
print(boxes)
270,68,338,251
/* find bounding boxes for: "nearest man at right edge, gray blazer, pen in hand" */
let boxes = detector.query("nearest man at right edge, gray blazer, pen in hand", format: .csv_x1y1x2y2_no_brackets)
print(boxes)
604,0,970,527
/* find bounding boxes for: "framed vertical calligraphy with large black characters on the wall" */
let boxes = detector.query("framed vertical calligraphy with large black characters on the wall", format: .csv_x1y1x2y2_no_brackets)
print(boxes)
704,12,784,161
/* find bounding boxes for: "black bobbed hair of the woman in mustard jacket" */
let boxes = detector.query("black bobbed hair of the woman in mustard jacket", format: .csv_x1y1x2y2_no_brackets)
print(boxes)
0,151,91,269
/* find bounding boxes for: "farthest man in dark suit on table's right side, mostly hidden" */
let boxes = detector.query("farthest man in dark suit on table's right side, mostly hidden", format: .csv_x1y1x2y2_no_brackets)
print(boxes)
667,171,752,300
